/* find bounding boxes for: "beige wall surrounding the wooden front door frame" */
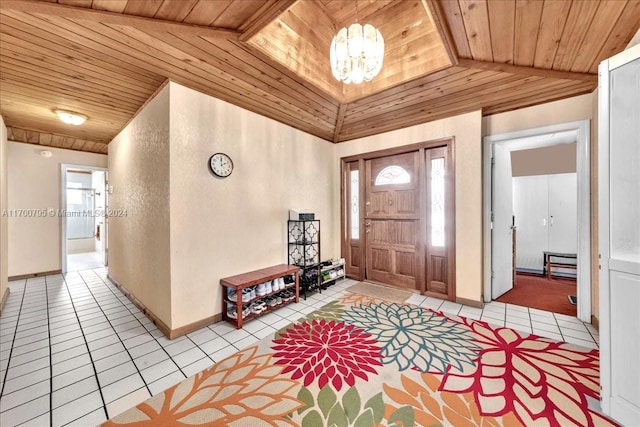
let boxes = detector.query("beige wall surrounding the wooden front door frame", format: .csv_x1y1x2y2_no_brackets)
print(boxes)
333,111,482,302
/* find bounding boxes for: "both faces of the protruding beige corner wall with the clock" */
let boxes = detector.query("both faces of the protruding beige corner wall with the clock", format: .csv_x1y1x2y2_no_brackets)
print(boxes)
109,83,339,329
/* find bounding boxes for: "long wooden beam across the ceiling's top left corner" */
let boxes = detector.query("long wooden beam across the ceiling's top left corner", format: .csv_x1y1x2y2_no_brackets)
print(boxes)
0,0,240,40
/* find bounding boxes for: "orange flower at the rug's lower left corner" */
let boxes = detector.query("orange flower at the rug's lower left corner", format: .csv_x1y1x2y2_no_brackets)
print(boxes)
103,346,303,427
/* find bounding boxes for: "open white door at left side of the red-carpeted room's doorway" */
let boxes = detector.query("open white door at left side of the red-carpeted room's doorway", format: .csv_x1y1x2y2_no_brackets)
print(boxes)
491,144,513,299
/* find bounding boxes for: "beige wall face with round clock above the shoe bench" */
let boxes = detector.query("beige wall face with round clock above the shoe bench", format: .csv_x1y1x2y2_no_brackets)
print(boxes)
171,83,339,328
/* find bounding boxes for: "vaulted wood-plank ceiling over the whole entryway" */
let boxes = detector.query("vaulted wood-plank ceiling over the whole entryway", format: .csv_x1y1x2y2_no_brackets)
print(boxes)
0,0,640,153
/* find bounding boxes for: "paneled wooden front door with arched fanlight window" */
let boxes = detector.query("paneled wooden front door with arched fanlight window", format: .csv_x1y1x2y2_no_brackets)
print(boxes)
364,151,423,290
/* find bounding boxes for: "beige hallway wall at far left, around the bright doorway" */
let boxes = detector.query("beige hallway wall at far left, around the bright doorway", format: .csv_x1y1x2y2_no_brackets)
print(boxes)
7,141,107,277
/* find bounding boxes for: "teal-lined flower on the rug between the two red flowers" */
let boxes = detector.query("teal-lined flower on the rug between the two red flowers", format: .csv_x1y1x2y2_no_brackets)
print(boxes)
342,302,478,372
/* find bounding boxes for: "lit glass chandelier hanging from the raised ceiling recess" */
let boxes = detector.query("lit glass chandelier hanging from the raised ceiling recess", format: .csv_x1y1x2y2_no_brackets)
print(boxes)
329,22,384,84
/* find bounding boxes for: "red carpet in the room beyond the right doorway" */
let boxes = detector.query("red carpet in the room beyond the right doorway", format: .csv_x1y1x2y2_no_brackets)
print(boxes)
496,274,576,316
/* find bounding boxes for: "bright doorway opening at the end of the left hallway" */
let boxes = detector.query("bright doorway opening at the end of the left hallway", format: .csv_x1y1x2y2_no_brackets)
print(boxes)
60,164,108,273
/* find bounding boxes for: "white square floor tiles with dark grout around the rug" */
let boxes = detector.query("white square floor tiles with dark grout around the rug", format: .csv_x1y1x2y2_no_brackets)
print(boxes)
0,268,598,427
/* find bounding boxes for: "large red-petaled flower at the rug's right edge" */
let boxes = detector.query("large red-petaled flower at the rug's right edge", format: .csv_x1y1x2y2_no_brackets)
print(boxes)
440,322,608,426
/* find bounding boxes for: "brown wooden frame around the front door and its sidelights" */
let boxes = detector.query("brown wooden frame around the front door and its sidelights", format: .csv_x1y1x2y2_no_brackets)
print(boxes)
340,137,456,301
